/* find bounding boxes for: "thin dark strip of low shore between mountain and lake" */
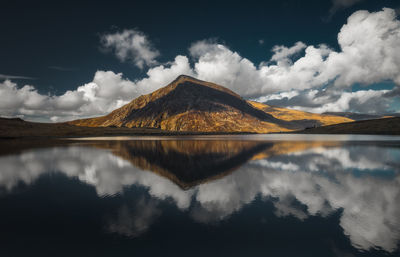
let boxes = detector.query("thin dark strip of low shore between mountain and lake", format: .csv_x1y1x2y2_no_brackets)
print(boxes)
0,117,400,140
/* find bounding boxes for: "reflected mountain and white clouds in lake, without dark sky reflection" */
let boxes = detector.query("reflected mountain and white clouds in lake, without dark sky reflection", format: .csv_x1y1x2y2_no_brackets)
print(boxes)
0,137,400,255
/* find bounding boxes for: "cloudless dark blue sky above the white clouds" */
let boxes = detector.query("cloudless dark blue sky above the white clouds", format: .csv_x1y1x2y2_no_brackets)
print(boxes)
0,0,400,94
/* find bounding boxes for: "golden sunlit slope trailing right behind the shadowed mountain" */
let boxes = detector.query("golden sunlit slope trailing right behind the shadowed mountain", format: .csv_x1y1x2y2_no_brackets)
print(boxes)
248,101,353,126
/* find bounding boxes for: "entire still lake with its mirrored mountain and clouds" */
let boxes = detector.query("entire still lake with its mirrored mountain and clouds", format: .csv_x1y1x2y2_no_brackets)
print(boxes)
0,135,400,256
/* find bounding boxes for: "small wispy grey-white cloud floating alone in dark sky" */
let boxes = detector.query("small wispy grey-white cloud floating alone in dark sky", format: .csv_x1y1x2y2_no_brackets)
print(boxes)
101,29,160,69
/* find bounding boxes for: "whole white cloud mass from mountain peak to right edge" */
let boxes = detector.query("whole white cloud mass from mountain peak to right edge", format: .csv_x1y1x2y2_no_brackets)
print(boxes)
190,8,400,112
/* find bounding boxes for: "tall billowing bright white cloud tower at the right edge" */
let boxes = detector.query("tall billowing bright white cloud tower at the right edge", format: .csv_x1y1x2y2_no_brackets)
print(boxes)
324,8,400,86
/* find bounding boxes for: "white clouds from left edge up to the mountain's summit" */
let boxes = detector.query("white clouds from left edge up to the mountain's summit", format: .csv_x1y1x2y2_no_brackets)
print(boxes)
0,56,193,121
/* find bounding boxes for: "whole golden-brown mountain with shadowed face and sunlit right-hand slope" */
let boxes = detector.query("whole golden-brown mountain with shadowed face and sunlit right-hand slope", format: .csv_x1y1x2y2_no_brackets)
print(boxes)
68,75,352,133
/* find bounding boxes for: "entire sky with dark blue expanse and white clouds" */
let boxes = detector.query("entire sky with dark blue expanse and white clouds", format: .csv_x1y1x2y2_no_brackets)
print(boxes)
0,0,400,122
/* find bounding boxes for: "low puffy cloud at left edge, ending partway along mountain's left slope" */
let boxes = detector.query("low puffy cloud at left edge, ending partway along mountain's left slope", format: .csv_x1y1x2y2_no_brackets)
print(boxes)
0,71,135,121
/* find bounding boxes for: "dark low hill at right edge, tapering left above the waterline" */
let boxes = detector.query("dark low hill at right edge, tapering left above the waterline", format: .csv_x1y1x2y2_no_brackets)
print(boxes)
299,117,400,135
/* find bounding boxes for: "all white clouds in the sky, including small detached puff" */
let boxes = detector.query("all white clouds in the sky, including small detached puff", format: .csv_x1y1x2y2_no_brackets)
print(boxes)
0,8,400,121
